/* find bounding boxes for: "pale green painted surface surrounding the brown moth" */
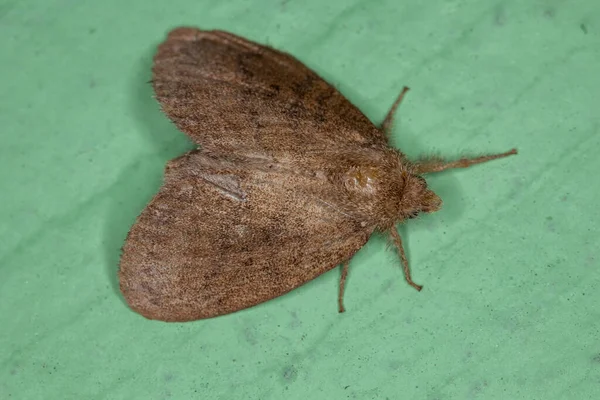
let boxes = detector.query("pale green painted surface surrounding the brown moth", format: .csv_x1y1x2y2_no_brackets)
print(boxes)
0,0,600,400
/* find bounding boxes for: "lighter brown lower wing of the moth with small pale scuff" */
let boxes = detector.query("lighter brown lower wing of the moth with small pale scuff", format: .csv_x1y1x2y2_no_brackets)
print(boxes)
119,150,371,321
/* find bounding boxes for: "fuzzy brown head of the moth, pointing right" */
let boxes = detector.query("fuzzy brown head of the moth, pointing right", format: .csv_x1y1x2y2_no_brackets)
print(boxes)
400,172,442,219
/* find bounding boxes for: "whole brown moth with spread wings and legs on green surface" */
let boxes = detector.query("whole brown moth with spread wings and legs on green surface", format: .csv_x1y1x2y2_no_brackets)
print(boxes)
119,27,516,321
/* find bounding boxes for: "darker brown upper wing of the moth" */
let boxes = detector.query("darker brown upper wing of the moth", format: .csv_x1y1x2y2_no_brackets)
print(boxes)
152,28,386,155
